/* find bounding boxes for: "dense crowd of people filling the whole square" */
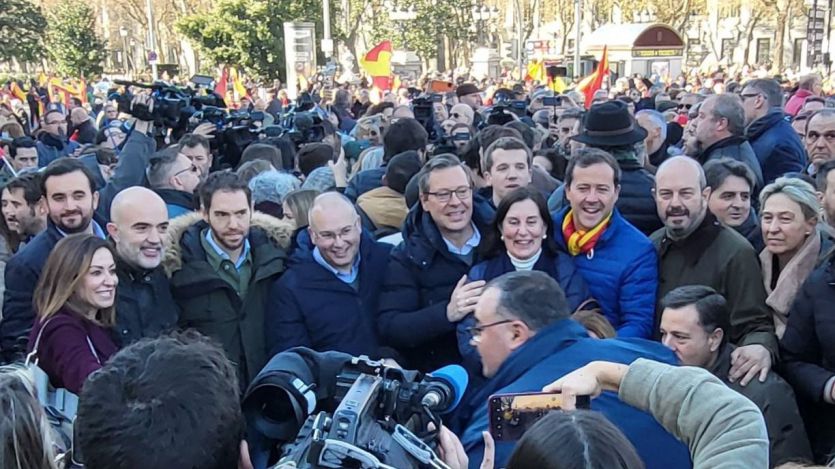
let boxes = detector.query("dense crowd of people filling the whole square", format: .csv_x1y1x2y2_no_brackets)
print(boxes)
0,68,835,469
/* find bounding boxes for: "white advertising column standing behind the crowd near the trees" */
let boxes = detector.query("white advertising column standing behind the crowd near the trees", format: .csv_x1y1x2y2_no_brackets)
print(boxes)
284,23,316,99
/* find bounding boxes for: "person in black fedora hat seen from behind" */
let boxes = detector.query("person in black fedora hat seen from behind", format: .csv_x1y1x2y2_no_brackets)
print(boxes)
548,101,663,236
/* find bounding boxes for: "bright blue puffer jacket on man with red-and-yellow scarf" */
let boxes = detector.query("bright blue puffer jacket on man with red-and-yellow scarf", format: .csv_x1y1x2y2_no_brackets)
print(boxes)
554,208,658,339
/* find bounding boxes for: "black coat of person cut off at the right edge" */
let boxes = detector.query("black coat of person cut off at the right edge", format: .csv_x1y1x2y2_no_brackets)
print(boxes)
780,252,835,463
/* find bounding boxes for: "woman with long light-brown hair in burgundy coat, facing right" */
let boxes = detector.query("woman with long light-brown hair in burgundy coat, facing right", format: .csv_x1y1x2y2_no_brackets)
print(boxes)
28,234,119,394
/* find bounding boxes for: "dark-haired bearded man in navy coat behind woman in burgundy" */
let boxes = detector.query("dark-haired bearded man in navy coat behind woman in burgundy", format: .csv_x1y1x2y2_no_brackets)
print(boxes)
0,158,105,361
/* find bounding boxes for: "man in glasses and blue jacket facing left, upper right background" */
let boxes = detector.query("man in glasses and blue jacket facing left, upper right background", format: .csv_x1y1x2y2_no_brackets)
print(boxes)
740,79,806,184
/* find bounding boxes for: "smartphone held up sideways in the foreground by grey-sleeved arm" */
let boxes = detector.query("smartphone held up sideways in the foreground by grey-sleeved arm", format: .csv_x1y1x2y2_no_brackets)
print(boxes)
487,392,590,441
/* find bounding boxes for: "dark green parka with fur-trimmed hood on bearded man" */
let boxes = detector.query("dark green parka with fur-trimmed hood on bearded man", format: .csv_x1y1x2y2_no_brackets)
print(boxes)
163,213,293,387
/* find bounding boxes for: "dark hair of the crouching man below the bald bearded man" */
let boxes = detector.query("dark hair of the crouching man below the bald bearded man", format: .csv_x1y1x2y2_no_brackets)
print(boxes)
661,285,731,344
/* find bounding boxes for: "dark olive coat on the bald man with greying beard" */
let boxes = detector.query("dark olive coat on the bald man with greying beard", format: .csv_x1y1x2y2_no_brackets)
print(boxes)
650,212,777,357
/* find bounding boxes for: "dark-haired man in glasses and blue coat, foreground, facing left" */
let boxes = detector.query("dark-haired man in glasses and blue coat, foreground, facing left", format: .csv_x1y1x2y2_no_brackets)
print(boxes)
457,271,691,469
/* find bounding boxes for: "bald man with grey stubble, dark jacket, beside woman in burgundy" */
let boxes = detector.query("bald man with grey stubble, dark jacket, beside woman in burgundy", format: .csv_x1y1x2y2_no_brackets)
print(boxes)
107,186,180,347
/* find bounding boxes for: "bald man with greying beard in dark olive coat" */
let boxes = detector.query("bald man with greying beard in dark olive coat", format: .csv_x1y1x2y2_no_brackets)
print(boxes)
651,156,777,386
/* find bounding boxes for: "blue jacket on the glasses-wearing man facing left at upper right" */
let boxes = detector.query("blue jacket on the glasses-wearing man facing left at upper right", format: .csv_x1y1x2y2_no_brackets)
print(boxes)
745,108,806,184
